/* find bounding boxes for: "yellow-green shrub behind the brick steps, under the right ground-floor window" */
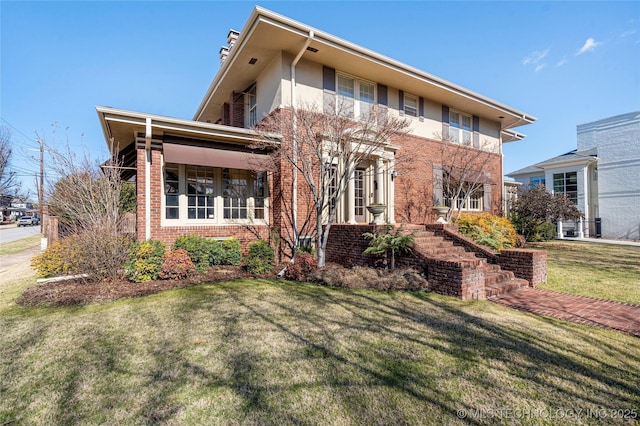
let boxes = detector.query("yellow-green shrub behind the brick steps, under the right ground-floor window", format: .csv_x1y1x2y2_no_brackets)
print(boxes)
456,213,517,250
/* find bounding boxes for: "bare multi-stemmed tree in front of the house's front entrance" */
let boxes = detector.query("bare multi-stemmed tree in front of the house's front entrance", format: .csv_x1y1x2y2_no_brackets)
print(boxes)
259,103,408,267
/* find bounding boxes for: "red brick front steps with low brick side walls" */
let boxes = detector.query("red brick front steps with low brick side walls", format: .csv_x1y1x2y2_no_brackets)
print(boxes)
327,224,546,300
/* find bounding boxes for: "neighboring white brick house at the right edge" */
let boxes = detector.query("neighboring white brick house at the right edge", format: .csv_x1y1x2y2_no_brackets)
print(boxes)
507,111,640,240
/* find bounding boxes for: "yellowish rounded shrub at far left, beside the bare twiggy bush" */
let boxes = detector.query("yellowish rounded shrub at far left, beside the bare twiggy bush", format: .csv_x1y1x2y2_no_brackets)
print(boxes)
31,235,81,278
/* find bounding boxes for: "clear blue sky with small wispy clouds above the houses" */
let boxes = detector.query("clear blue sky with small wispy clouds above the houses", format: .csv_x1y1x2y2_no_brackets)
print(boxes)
0,0,640,199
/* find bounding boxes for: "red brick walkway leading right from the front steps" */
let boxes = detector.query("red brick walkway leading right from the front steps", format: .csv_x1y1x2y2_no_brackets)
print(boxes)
488,287,640,337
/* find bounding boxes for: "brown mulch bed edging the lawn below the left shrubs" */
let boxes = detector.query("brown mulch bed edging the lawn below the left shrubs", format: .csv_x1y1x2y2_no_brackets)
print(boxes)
16,266,272,306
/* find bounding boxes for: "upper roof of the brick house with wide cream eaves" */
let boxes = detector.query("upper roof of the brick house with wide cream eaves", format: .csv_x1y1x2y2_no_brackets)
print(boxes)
193,6,536,131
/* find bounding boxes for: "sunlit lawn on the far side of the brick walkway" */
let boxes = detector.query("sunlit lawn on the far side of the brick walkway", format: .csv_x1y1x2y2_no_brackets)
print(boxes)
538,241,640,304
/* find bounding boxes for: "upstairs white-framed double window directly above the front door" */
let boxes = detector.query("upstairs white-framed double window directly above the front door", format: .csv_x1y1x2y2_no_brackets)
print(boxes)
336,73,376,120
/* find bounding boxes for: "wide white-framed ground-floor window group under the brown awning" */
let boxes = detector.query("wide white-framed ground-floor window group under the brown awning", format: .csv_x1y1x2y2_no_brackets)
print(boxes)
163,163,268,225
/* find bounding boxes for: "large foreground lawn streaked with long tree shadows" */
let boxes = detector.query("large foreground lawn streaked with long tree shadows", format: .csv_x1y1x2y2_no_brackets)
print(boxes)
0,246,640,425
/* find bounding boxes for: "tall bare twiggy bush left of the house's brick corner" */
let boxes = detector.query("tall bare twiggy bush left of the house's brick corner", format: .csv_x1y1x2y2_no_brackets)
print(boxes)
47,141,129,280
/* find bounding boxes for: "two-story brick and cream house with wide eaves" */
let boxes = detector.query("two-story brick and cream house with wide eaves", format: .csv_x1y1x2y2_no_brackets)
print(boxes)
97,7,535,256
